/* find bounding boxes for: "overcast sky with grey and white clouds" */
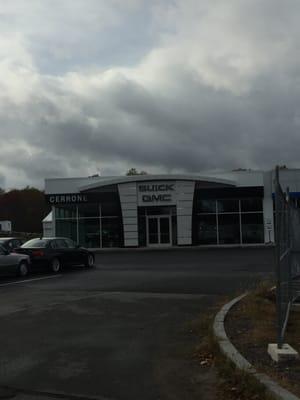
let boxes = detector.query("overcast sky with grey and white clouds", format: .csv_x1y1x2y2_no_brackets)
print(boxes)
0,0,300,188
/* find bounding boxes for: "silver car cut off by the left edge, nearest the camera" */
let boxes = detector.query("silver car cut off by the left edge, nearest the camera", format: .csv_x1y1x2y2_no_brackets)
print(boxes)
0,245,30,277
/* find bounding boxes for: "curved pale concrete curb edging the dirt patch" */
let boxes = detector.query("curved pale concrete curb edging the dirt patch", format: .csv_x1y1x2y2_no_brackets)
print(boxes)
213,292,300,400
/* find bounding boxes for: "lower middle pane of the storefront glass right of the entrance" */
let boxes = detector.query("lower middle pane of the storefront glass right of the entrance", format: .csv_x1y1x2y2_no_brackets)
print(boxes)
218,214,241,244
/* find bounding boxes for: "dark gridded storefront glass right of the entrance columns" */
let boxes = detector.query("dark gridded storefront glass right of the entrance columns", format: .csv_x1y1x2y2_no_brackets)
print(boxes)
193,198,264,244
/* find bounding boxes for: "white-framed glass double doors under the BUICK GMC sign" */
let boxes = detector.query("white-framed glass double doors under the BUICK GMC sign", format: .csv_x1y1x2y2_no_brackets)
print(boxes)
147,215,172,246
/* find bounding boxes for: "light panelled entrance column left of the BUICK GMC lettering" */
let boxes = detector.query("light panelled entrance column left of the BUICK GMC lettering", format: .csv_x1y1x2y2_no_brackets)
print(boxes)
118,182,139,247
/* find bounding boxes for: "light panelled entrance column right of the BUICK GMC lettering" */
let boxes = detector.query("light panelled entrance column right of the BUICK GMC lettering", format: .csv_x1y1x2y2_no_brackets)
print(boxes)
176,181,195,245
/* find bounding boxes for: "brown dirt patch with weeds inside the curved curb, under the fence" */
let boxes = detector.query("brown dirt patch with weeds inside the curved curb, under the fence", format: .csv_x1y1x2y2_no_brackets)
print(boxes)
225,285,300,396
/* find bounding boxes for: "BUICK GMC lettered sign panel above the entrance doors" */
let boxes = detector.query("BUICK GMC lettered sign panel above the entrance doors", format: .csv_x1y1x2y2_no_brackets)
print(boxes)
137,181,176,206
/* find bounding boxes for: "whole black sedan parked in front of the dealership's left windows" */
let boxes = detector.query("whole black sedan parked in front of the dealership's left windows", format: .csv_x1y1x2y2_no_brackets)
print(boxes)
16,237,95,273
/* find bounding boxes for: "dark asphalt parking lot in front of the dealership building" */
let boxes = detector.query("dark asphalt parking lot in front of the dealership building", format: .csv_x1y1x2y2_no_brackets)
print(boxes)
0,248,273,400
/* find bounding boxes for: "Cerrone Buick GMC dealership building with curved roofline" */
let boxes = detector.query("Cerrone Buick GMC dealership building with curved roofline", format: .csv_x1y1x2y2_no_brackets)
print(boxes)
45,169,300,248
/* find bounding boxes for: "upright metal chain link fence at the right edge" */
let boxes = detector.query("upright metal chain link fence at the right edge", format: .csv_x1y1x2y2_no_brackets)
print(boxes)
274,167,300,348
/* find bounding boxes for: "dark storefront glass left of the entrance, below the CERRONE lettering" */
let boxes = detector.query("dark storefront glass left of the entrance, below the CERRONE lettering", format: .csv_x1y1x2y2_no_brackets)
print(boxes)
55,201,123,248
